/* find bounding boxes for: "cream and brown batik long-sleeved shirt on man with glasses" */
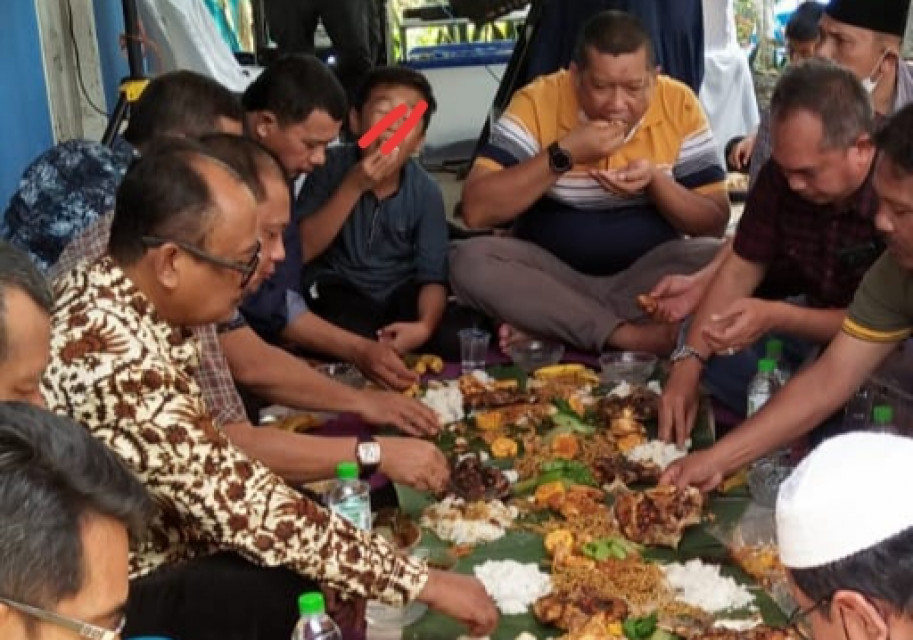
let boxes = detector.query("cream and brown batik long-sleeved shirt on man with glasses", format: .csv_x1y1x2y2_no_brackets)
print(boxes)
42,258,428,604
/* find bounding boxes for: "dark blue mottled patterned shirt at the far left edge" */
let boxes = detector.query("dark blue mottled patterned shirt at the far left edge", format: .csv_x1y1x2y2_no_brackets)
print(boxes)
0,138,136,270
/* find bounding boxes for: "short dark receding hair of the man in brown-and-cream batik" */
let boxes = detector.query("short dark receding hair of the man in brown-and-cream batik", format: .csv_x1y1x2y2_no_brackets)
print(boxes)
108,138,253,265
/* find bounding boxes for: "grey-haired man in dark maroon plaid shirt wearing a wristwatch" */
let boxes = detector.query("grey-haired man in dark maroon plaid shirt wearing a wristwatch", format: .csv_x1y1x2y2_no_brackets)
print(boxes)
660,61,879,444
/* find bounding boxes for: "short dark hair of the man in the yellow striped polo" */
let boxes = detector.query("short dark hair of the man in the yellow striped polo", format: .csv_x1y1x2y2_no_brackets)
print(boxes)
573,11,656,71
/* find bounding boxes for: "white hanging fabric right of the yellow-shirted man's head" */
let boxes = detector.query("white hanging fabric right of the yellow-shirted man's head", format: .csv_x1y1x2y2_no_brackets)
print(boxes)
700,0,760,158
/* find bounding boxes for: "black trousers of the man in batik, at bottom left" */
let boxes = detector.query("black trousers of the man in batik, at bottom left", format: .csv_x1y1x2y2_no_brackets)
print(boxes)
123,553,316,640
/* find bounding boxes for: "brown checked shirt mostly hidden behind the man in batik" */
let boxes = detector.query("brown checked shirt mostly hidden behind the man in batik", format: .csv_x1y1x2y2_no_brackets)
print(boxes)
49,213,247,428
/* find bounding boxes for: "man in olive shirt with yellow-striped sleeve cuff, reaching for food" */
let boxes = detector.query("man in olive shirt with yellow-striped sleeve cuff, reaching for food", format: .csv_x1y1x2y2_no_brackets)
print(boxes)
662,105,913,491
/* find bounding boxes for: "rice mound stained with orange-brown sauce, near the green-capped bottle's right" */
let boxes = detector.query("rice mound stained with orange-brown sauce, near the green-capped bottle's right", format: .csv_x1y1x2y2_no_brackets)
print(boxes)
419,497,517,545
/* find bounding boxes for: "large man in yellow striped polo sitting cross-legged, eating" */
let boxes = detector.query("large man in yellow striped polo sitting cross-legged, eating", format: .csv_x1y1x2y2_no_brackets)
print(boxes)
451,11,729,352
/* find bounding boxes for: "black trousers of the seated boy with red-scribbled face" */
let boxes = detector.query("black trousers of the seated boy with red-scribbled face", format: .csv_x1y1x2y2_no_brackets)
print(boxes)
304,276,488,362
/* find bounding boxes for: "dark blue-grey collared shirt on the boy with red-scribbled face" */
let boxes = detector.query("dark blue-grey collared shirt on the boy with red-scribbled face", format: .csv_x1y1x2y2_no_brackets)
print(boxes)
297,144,448,301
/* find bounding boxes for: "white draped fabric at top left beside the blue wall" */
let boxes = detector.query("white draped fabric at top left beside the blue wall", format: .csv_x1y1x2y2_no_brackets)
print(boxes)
136,0,256,93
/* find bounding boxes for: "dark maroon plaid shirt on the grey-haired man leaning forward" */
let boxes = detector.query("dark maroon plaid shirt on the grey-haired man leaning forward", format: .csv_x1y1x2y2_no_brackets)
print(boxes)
733,162,878,308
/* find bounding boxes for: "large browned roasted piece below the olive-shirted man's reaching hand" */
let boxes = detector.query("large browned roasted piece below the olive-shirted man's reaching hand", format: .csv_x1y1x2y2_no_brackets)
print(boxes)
615,486,704,549
